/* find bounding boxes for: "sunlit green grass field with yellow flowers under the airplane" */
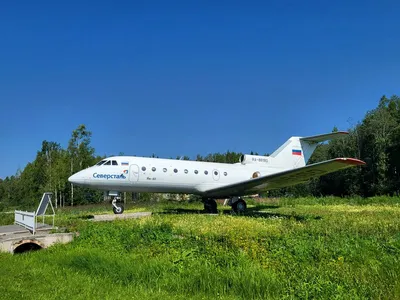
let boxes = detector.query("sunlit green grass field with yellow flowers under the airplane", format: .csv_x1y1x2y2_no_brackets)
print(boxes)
0,197,400,299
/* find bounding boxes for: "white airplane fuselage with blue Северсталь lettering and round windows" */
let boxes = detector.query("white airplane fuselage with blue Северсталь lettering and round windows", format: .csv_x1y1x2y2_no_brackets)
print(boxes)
69,156,292,195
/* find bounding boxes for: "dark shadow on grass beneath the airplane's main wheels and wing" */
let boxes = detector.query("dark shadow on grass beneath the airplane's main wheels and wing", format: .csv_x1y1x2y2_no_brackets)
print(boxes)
154,205,322,221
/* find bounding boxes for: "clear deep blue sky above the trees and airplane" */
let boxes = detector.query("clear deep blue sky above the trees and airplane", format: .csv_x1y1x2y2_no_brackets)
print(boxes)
0,0,400,178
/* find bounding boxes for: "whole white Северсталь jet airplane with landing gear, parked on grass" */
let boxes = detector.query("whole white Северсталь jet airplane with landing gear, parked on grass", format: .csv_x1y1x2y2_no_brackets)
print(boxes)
68,131,365,214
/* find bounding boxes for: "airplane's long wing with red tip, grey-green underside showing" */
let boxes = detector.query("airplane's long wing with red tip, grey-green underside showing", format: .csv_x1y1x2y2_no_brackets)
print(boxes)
204,158,365,197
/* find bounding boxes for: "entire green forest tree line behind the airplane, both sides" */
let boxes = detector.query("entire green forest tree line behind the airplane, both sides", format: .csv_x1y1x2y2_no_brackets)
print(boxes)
0,95,400,209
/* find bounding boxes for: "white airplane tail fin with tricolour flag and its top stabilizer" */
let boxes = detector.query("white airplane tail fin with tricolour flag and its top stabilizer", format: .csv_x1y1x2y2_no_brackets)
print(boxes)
270,131,348,169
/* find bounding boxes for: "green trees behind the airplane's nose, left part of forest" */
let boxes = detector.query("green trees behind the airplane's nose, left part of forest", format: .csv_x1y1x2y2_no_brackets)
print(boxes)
0,125,102,209
